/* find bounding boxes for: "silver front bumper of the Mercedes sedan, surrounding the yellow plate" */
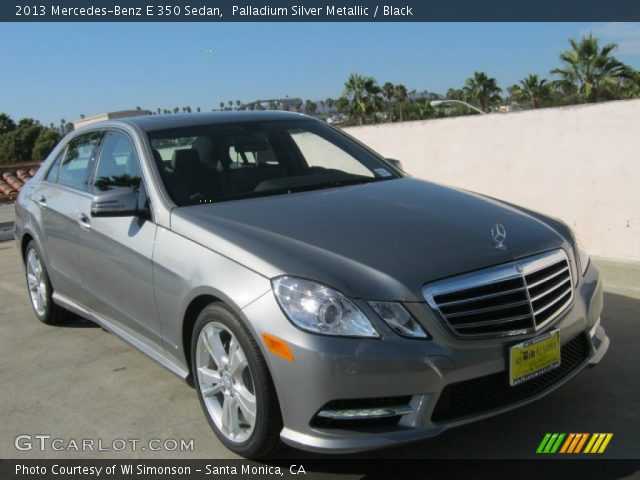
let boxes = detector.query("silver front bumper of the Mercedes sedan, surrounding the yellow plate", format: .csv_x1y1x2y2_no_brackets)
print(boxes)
243,265,609,453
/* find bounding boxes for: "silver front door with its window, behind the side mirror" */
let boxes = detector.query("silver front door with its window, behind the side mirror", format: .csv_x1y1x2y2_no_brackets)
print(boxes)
78,130,161,345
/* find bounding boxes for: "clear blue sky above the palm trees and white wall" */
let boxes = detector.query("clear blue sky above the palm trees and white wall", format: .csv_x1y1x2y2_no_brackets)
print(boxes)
0,23,640,124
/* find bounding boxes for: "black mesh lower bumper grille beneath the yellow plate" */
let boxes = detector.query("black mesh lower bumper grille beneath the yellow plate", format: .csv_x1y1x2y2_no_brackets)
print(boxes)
431,334,589,422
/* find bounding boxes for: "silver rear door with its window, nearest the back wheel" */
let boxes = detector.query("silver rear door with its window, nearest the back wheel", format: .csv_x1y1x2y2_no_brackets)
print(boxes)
32,132,102,302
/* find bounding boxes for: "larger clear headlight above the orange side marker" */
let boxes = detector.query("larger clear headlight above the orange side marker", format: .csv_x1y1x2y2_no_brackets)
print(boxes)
271,276,380,337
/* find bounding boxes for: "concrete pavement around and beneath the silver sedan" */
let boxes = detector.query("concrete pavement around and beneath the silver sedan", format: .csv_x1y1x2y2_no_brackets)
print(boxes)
0,242,640,459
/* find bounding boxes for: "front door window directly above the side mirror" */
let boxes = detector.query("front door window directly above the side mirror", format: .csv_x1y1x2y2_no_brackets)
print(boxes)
93,132,141,191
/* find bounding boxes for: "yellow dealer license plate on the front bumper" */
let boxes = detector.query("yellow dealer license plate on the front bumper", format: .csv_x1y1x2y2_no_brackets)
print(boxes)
509,330,560,386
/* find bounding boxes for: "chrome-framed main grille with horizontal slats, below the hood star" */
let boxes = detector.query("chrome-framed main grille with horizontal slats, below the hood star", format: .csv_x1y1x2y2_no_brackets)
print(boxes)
423,250,573,337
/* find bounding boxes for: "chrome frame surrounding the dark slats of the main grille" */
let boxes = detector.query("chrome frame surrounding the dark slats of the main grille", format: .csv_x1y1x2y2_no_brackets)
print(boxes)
422,248,576,340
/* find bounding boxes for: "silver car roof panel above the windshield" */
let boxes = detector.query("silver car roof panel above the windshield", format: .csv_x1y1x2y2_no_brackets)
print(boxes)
119,111,312,131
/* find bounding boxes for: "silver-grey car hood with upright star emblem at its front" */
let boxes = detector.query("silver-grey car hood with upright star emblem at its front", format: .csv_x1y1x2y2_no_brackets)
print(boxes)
171,178,569,301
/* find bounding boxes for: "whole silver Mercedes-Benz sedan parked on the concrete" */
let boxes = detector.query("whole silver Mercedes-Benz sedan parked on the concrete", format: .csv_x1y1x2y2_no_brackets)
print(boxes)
16,112,609,456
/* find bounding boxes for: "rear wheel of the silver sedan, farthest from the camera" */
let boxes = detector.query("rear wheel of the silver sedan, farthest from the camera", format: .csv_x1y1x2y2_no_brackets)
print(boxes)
24,240,68,325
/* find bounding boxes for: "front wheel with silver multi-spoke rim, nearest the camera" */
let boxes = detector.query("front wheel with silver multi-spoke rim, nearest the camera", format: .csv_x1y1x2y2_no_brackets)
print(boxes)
191,303,282,458
